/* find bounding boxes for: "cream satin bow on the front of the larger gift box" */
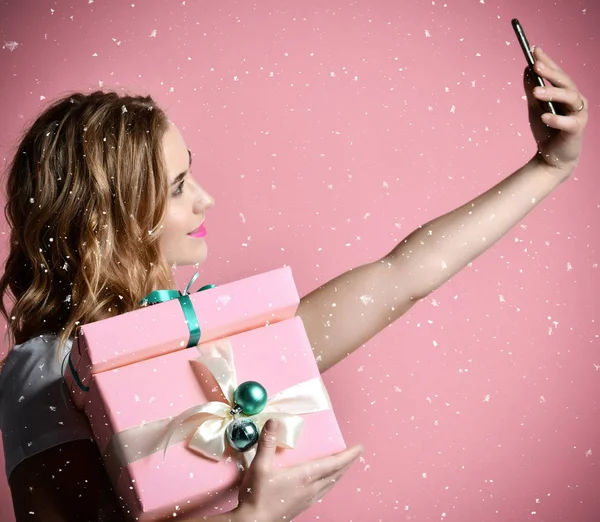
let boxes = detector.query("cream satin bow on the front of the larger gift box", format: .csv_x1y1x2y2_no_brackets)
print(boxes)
164,339,331,463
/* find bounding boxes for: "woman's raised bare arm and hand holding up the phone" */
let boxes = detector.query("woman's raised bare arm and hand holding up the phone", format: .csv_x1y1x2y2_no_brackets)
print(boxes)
298,48,588,372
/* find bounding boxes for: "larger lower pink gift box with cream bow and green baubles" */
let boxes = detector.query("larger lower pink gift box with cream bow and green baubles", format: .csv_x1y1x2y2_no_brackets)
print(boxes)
77,317,346,522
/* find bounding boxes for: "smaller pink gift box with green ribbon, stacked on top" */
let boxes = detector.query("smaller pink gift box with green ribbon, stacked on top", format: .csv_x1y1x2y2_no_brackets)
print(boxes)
65,267,300,407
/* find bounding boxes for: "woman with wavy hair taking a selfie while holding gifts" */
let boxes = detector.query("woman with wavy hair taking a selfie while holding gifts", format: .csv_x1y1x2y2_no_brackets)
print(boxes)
0,48,588,522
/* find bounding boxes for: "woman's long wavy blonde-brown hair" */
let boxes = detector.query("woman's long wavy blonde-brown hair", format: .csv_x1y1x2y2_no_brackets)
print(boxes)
0,91,173,356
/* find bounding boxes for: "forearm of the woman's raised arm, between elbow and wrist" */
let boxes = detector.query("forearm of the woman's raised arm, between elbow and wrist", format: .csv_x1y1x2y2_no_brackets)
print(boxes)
387,154,560,297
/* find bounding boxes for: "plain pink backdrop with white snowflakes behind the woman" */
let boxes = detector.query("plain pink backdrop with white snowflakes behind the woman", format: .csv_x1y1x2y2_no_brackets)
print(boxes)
0,0,600,522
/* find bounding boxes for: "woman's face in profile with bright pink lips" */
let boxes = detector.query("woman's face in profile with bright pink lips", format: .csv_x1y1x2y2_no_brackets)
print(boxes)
159,123,214,266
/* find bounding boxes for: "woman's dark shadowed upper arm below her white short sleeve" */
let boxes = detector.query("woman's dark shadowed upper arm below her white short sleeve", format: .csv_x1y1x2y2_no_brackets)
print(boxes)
9,440,123,522
